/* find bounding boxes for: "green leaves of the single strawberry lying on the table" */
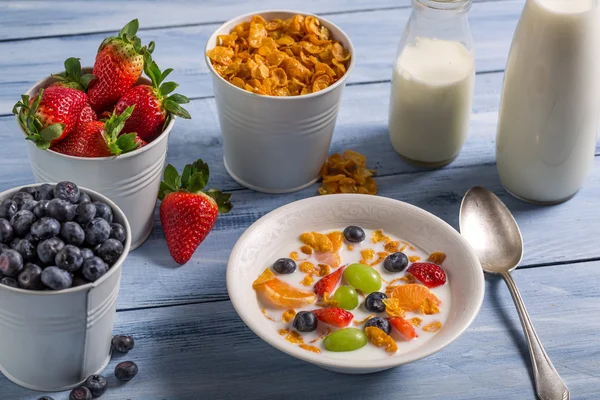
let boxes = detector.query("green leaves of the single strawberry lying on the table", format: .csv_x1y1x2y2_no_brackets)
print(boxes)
158,160,233,214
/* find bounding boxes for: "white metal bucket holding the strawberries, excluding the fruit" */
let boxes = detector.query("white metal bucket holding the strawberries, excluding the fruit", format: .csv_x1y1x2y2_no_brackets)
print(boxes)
17,68,175,250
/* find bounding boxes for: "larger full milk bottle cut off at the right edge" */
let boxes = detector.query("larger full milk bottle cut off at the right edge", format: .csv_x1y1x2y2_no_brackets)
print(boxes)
496,0,600,204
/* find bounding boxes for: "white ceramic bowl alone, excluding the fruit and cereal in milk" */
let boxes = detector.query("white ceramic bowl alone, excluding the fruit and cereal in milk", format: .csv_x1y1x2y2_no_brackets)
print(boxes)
227,194,484,374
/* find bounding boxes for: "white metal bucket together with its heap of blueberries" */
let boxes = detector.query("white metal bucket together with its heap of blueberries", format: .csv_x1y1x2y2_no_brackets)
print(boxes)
0,182,131,391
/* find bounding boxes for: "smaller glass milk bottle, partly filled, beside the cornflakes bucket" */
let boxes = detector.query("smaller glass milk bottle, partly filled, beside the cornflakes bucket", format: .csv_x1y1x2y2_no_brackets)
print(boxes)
389,0,475,167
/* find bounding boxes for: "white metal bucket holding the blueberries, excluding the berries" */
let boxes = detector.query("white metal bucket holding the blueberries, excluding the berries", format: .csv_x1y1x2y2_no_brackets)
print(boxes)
0,185,131,391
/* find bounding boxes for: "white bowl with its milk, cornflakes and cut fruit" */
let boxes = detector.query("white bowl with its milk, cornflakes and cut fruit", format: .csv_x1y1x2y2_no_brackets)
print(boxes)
227,194,484,374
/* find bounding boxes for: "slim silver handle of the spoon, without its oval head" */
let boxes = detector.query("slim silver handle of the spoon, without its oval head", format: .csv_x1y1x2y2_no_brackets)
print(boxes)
502,272,570,400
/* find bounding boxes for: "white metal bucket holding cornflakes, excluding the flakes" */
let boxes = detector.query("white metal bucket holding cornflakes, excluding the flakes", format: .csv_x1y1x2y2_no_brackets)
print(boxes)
205,11,355,193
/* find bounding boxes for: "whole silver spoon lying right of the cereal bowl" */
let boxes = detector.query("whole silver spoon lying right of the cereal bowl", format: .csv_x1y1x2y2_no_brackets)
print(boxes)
460,186,570,400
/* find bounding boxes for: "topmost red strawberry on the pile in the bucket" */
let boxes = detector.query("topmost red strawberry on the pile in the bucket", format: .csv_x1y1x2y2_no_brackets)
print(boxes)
88,19,154,113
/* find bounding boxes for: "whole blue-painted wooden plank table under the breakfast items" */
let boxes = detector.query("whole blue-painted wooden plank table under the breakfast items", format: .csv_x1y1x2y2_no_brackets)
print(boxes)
0,0,600,400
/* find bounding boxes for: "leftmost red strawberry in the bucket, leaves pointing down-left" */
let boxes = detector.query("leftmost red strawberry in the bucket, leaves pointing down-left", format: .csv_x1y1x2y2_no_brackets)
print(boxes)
13,86,88,150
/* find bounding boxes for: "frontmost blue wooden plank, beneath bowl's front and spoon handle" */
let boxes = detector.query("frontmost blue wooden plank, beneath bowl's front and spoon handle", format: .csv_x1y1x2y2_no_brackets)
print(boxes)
9,262,600,400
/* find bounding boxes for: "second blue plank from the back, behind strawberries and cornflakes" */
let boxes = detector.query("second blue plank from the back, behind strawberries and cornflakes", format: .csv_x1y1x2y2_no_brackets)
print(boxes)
0,1,522,115
